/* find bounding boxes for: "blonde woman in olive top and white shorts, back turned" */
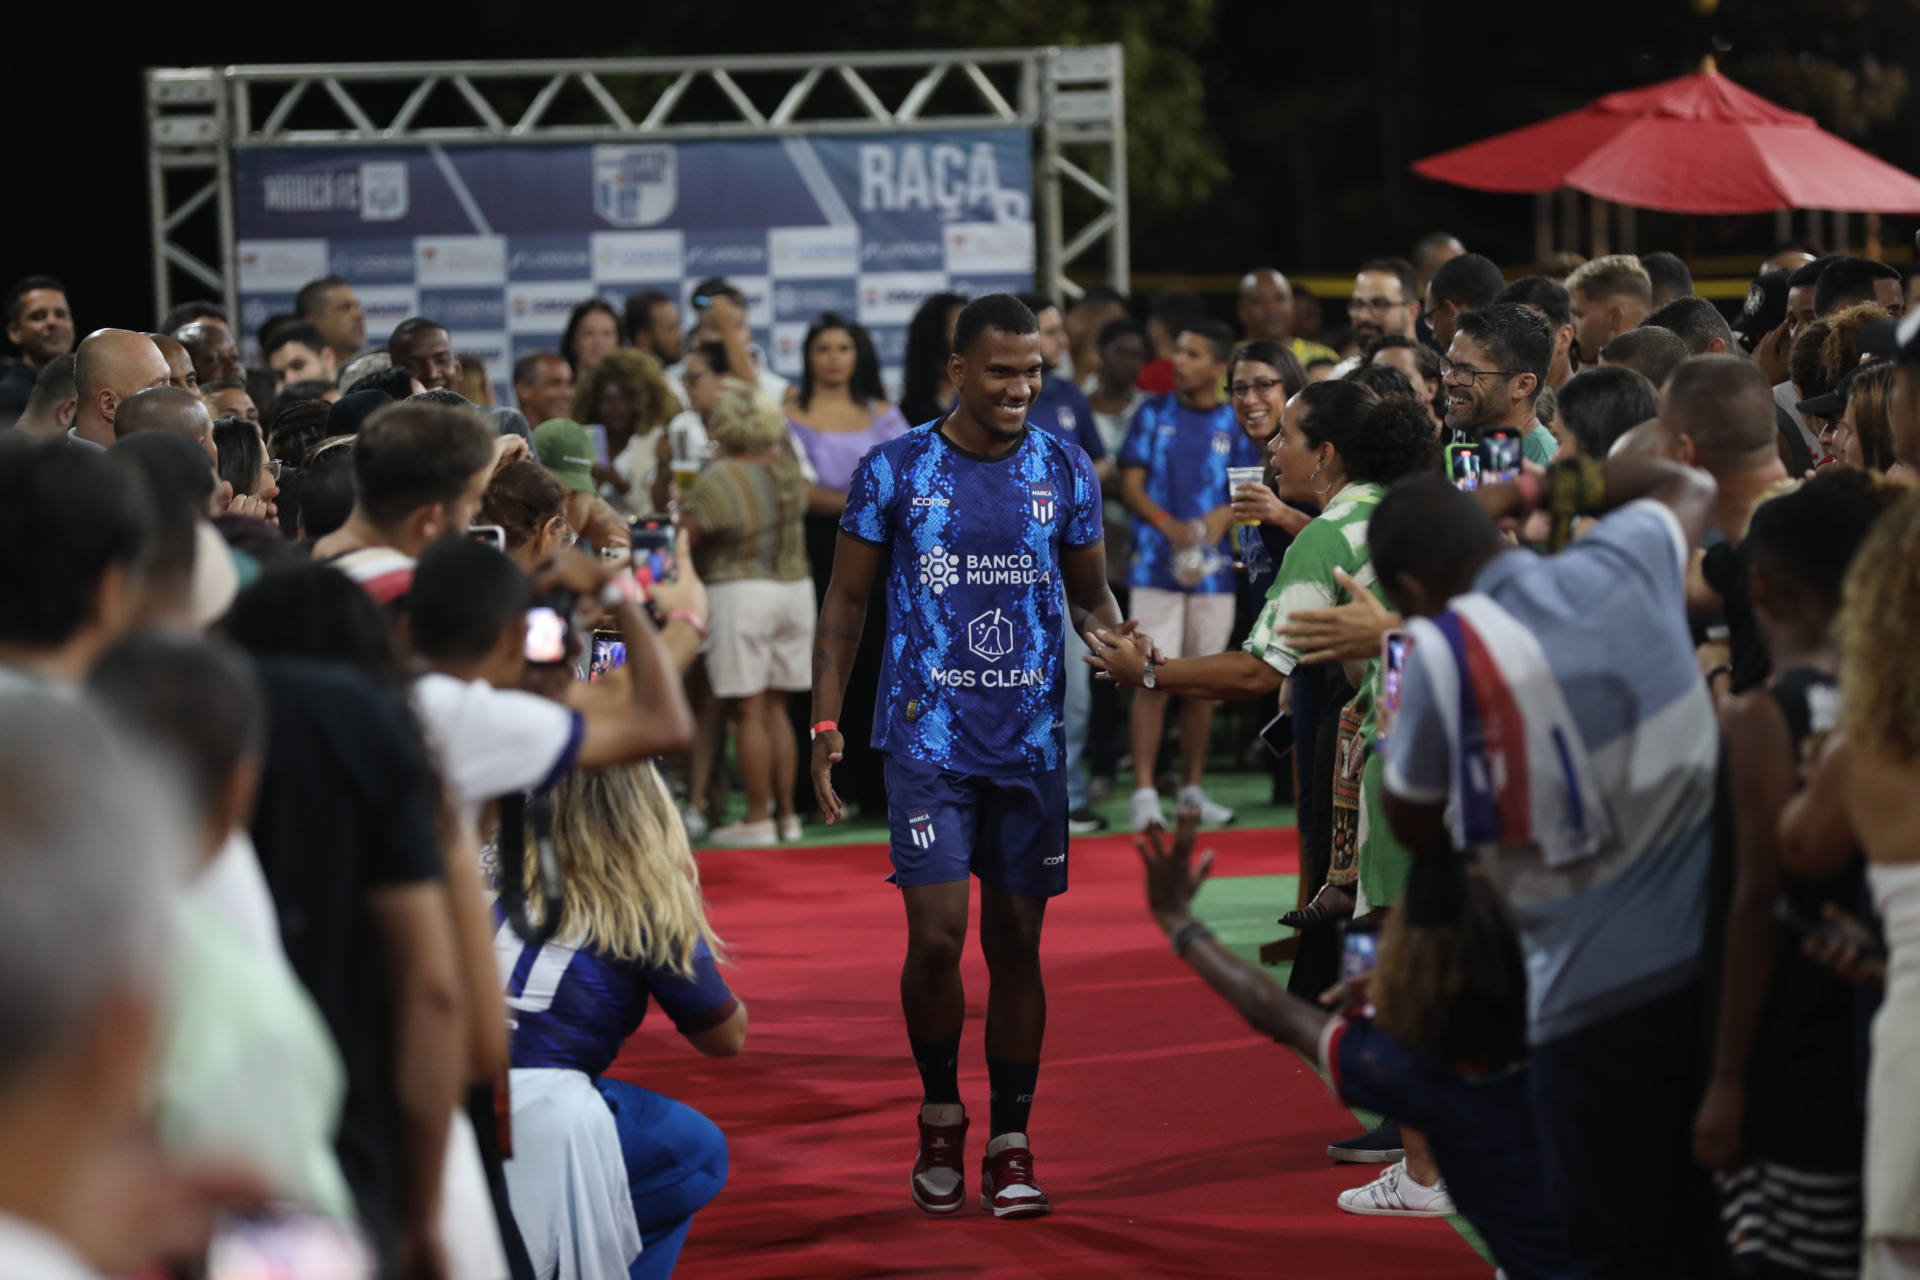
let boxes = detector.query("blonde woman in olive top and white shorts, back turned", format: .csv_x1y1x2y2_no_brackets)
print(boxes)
680,378,814,846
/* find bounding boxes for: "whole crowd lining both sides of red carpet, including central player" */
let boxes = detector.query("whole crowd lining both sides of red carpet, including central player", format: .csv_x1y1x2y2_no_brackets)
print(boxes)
0,225,1920,1280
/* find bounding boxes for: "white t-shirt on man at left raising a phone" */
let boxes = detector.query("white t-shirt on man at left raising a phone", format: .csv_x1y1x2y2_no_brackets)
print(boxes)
413,672,586,831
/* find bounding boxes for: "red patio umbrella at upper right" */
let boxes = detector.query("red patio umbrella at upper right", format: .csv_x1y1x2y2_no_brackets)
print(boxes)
1413,58,1920,213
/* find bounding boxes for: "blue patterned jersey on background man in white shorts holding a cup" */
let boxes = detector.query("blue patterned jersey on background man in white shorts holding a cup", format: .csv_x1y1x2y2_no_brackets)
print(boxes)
1119,393,1260,595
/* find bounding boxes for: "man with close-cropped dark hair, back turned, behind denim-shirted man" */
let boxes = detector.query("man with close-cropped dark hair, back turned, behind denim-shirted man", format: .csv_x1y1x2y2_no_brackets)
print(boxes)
1659,355,1788,697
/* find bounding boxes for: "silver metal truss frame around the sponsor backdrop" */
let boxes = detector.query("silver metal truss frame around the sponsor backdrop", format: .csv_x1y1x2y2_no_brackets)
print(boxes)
146,44,1129,328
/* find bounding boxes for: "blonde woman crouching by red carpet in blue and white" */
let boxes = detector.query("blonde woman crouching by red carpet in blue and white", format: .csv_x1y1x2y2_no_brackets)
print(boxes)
493,762,747,1280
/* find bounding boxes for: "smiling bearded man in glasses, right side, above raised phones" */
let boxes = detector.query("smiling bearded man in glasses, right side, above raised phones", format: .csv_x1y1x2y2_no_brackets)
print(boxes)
1440,303,1559,466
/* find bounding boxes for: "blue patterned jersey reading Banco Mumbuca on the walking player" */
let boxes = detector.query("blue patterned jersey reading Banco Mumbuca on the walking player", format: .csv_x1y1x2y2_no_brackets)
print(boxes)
841,420,1102,777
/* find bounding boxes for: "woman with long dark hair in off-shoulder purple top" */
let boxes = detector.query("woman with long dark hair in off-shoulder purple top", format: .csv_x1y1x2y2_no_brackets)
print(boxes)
787,311,910,502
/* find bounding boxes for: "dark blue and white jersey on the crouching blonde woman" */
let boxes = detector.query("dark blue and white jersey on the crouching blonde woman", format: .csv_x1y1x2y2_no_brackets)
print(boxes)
493,904,737,1077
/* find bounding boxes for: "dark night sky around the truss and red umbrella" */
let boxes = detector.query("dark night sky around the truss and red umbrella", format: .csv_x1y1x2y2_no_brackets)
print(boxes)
15,0,1920,332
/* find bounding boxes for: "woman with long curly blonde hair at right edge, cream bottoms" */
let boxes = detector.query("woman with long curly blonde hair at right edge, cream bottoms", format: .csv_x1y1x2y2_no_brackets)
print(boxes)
1780,497,1920,1276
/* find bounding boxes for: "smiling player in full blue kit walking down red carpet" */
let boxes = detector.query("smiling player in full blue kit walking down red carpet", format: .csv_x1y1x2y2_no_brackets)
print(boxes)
812,294,1133,1219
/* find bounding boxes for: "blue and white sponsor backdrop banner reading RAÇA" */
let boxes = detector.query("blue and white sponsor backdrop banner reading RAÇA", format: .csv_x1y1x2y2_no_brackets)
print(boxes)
236,129,1033,403
